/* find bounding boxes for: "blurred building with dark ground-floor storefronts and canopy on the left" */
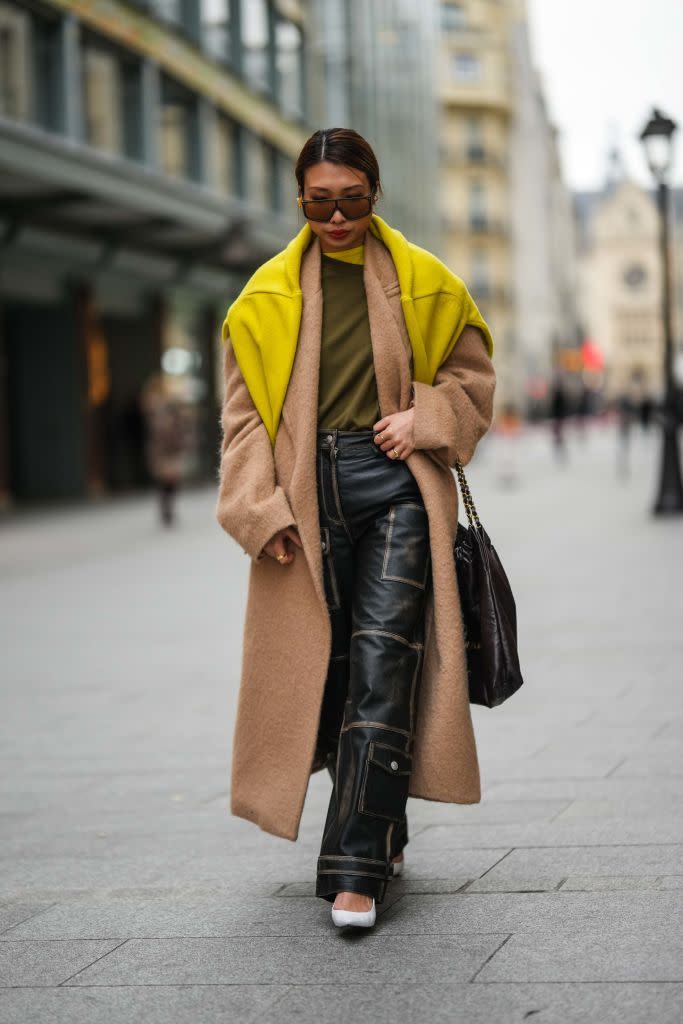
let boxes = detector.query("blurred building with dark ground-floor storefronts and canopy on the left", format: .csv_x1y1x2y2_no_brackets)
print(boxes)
0,0,309,501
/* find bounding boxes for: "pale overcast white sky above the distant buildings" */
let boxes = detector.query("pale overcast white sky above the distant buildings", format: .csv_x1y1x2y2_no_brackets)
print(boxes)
528,0,683,188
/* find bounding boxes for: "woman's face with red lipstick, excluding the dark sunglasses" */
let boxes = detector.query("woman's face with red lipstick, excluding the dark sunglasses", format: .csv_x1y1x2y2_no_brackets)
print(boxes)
302,160,375,252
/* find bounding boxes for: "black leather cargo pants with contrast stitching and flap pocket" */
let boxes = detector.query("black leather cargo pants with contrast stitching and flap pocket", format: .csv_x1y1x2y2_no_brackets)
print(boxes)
315,429,431,903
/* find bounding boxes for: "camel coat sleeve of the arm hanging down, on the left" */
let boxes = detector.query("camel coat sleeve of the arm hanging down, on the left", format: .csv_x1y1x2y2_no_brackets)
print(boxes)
216,336,295,561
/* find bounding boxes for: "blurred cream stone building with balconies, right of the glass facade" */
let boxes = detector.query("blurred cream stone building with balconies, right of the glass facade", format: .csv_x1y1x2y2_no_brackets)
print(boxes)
438,0,578,415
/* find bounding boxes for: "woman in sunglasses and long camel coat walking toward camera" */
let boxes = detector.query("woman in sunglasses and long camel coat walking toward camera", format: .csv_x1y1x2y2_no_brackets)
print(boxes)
216,129,496,927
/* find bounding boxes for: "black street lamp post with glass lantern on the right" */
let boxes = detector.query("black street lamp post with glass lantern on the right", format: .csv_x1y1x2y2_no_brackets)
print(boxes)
640,109,683,515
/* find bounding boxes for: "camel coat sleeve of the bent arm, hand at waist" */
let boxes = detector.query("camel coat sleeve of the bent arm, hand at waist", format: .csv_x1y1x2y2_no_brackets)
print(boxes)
413,325,496,467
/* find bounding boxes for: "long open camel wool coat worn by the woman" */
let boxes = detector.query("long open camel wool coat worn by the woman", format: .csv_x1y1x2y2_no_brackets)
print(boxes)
216,231,496,840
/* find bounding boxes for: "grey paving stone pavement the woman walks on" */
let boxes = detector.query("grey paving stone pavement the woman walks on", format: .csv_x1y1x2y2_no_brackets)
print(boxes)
0,425,683,1024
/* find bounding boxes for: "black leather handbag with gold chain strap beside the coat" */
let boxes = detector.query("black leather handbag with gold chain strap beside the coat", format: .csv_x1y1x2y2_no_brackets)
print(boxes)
453,463,523,708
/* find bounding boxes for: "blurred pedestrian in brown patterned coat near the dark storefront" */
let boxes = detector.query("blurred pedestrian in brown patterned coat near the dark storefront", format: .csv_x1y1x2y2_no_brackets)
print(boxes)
140,373,187,526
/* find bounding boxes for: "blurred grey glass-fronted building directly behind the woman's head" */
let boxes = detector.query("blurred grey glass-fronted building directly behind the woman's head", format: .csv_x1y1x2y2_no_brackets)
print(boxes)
307,0,441,252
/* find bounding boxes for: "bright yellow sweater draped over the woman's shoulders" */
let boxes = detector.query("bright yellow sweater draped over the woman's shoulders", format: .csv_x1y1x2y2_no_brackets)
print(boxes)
221,213,494,445
